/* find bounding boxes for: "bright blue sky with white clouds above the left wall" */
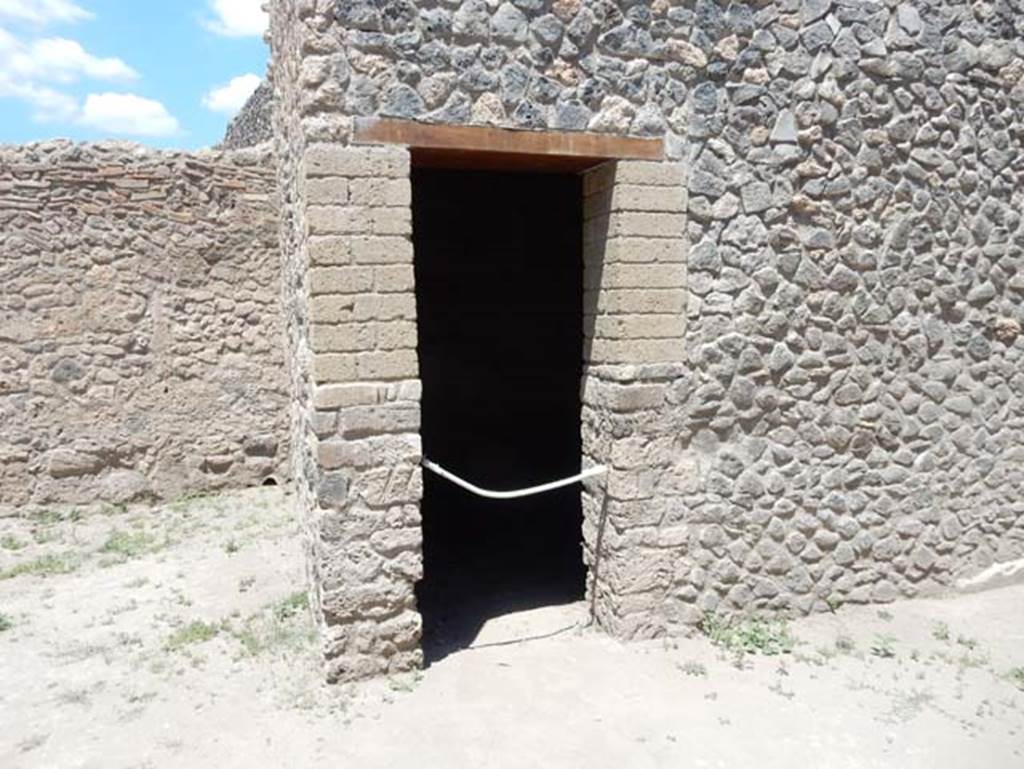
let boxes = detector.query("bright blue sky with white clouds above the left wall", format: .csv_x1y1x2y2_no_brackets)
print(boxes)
0,0,267,148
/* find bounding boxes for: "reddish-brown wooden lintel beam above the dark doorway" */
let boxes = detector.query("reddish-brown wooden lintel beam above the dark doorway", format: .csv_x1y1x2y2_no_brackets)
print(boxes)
354,118,665,160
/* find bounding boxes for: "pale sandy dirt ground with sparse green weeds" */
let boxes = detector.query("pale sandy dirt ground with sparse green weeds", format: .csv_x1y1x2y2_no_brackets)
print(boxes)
0,488,1024,769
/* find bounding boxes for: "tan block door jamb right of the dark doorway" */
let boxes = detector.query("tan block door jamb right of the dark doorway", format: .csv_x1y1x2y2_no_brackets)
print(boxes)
582,154,688,639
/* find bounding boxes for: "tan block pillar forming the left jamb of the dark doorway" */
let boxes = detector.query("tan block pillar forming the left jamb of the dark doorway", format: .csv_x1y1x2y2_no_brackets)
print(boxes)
276,135,422,681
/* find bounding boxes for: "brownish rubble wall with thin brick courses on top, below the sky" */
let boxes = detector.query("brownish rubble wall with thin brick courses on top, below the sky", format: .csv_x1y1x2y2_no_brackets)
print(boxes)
0,142,288,506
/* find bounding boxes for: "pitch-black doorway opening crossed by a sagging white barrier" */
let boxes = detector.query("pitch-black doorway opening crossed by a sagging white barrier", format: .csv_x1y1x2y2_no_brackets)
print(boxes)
413,168,586,664
